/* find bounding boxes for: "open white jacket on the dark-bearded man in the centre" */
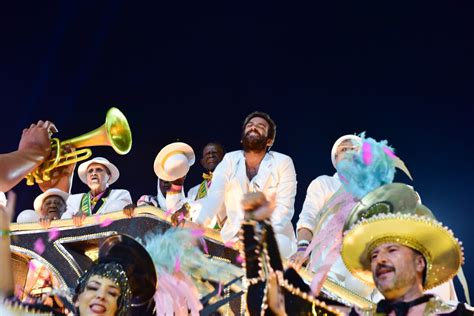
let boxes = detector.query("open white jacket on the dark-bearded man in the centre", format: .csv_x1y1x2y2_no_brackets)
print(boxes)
190,150,296,257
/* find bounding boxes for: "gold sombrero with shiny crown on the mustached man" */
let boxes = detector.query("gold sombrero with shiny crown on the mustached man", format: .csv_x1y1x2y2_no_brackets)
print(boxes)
341,183,464,290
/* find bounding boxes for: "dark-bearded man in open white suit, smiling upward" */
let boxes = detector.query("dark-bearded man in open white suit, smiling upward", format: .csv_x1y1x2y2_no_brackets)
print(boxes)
173,112,296,257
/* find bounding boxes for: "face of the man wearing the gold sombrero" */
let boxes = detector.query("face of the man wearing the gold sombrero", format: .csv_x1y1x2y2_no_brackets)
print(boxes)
370,243,426,300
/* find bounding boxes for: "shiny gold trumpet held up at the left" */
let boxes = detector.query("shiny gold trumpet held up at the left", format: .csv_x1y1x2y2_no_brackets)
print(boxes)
26,108,132,185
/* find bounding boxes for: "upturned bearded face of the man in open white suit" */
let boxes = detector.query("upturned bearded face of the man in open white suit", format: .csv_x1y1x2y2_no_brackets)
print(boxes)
242,116,273,152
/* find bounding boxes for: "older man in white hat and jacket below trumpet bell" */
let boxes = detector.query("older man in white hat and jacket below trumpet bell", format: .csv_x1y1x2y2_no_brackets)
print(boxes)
61,157,132,225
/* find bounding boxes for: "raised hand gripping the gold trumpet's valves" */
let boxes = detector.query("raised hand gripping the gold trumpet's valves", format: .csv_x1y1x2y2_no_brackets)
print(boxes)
18,121,58,157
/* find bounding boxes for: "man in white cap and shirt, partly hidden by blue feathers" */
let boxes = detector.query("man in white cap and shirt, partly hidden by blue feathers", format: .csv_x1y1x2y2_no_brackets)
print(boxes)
292,134,360,261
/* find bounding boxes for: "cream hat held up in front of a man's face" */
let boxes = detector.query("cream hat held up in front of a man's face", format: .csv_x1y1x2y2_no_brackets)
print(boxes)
153,142,196,181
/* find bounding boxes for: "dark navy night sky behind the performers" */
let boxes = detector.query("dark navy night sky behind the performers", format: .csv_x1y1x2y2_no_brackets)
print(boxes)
0,1,474,297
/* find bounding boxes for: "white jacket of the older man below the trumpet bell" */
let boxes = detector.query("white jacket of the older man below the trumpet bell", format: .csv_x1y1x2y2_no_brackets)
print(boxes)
61,189,132,219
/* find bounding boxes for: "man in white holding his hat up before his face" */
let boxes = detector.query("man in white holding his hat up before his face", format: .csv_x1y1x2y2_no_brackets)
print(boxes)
137,142,196,213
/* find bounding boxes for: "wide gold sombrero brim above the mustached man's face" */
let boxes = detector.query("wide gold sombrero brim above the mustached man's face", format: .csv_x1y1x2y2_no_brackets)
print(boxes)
341,213,464,290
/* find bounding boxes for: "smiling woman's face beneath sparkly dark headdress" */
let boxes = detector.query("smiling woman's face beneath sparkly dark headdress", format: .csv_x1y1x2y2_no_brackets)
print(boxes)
75,275,121,316
